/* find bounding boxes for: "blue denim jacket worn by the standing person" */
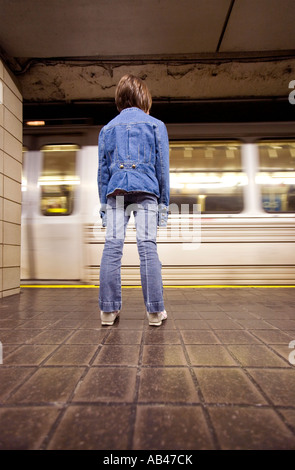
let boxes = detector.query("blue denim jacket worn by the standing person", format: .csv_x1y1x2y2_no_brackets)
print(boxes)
97,107,170,226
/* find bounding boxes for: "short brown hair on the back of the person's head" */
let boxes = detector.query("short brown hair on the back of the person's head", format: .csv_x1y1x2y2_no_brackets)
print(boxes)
115,74,152,113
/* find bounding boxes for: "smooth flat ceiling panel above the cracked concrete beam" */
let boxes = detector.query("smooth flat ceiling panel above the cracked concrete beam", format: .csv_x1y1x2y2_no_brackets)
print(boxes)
0,0,295,58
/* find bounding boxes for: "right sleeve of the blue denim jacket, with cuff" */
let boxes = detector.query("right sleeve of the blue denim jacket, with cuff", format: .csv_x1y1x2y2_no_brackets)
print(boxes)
156,122,170,227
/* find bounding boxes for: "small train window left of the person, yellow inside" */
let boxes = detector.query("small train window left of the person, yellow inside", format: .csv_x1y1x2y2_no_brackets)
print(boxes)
39,145,80,216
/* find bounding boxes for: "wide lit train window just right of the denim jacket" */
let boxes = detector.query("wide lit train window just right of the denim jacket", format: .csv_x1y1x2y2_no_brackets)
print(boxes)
170,141,247,213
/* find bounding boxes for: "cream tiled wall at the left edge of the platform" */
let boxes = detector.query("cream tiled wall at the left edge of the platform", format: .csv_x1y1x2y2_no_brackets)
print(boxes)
0,61,22,297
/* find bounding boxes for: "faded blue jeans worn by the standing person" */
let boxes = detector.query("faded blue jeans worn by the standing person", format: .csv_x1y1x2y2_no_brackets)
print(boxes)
99,193,164,313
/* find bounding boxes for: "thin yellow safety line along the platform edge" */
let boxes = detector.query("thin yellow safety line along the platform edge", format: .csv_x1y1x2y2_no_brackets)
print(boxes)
20,284,295,289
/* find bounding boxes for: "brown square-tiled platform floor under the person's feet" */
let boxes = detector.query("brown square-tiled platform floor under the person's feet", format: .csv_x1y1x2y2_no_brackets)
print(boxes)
0,288,295,450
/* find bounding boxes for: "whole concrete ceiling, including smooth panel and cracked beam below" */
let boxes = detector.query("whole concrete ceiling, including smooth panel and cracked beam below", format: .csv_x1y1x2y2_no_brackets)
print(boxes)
0,0,295,123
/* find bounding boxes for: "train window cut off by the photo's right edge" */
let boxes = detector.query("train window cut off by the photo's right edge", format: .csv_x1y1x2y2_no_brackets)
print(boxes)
256,140,295,212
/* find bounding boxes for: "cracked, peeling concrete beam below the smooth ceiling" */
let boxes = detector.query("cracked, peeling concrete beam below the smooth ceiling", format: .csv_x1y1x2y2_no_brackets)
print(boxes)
18,58,295,102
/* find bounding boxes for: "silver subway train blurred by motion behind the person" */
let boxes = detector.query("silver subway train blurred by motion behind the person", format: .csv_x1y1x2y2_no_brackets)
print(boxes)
21,122,295,286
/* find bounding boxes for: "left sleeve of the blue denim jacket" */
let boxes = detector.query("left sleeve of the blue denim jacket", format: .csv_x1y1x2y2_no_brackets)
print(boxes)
97,129,110,227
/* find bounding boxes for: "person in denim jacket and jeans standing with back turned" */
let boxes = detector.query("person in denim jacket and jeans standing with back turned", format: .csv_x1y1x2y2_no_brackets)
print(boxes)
98,75,169,325
